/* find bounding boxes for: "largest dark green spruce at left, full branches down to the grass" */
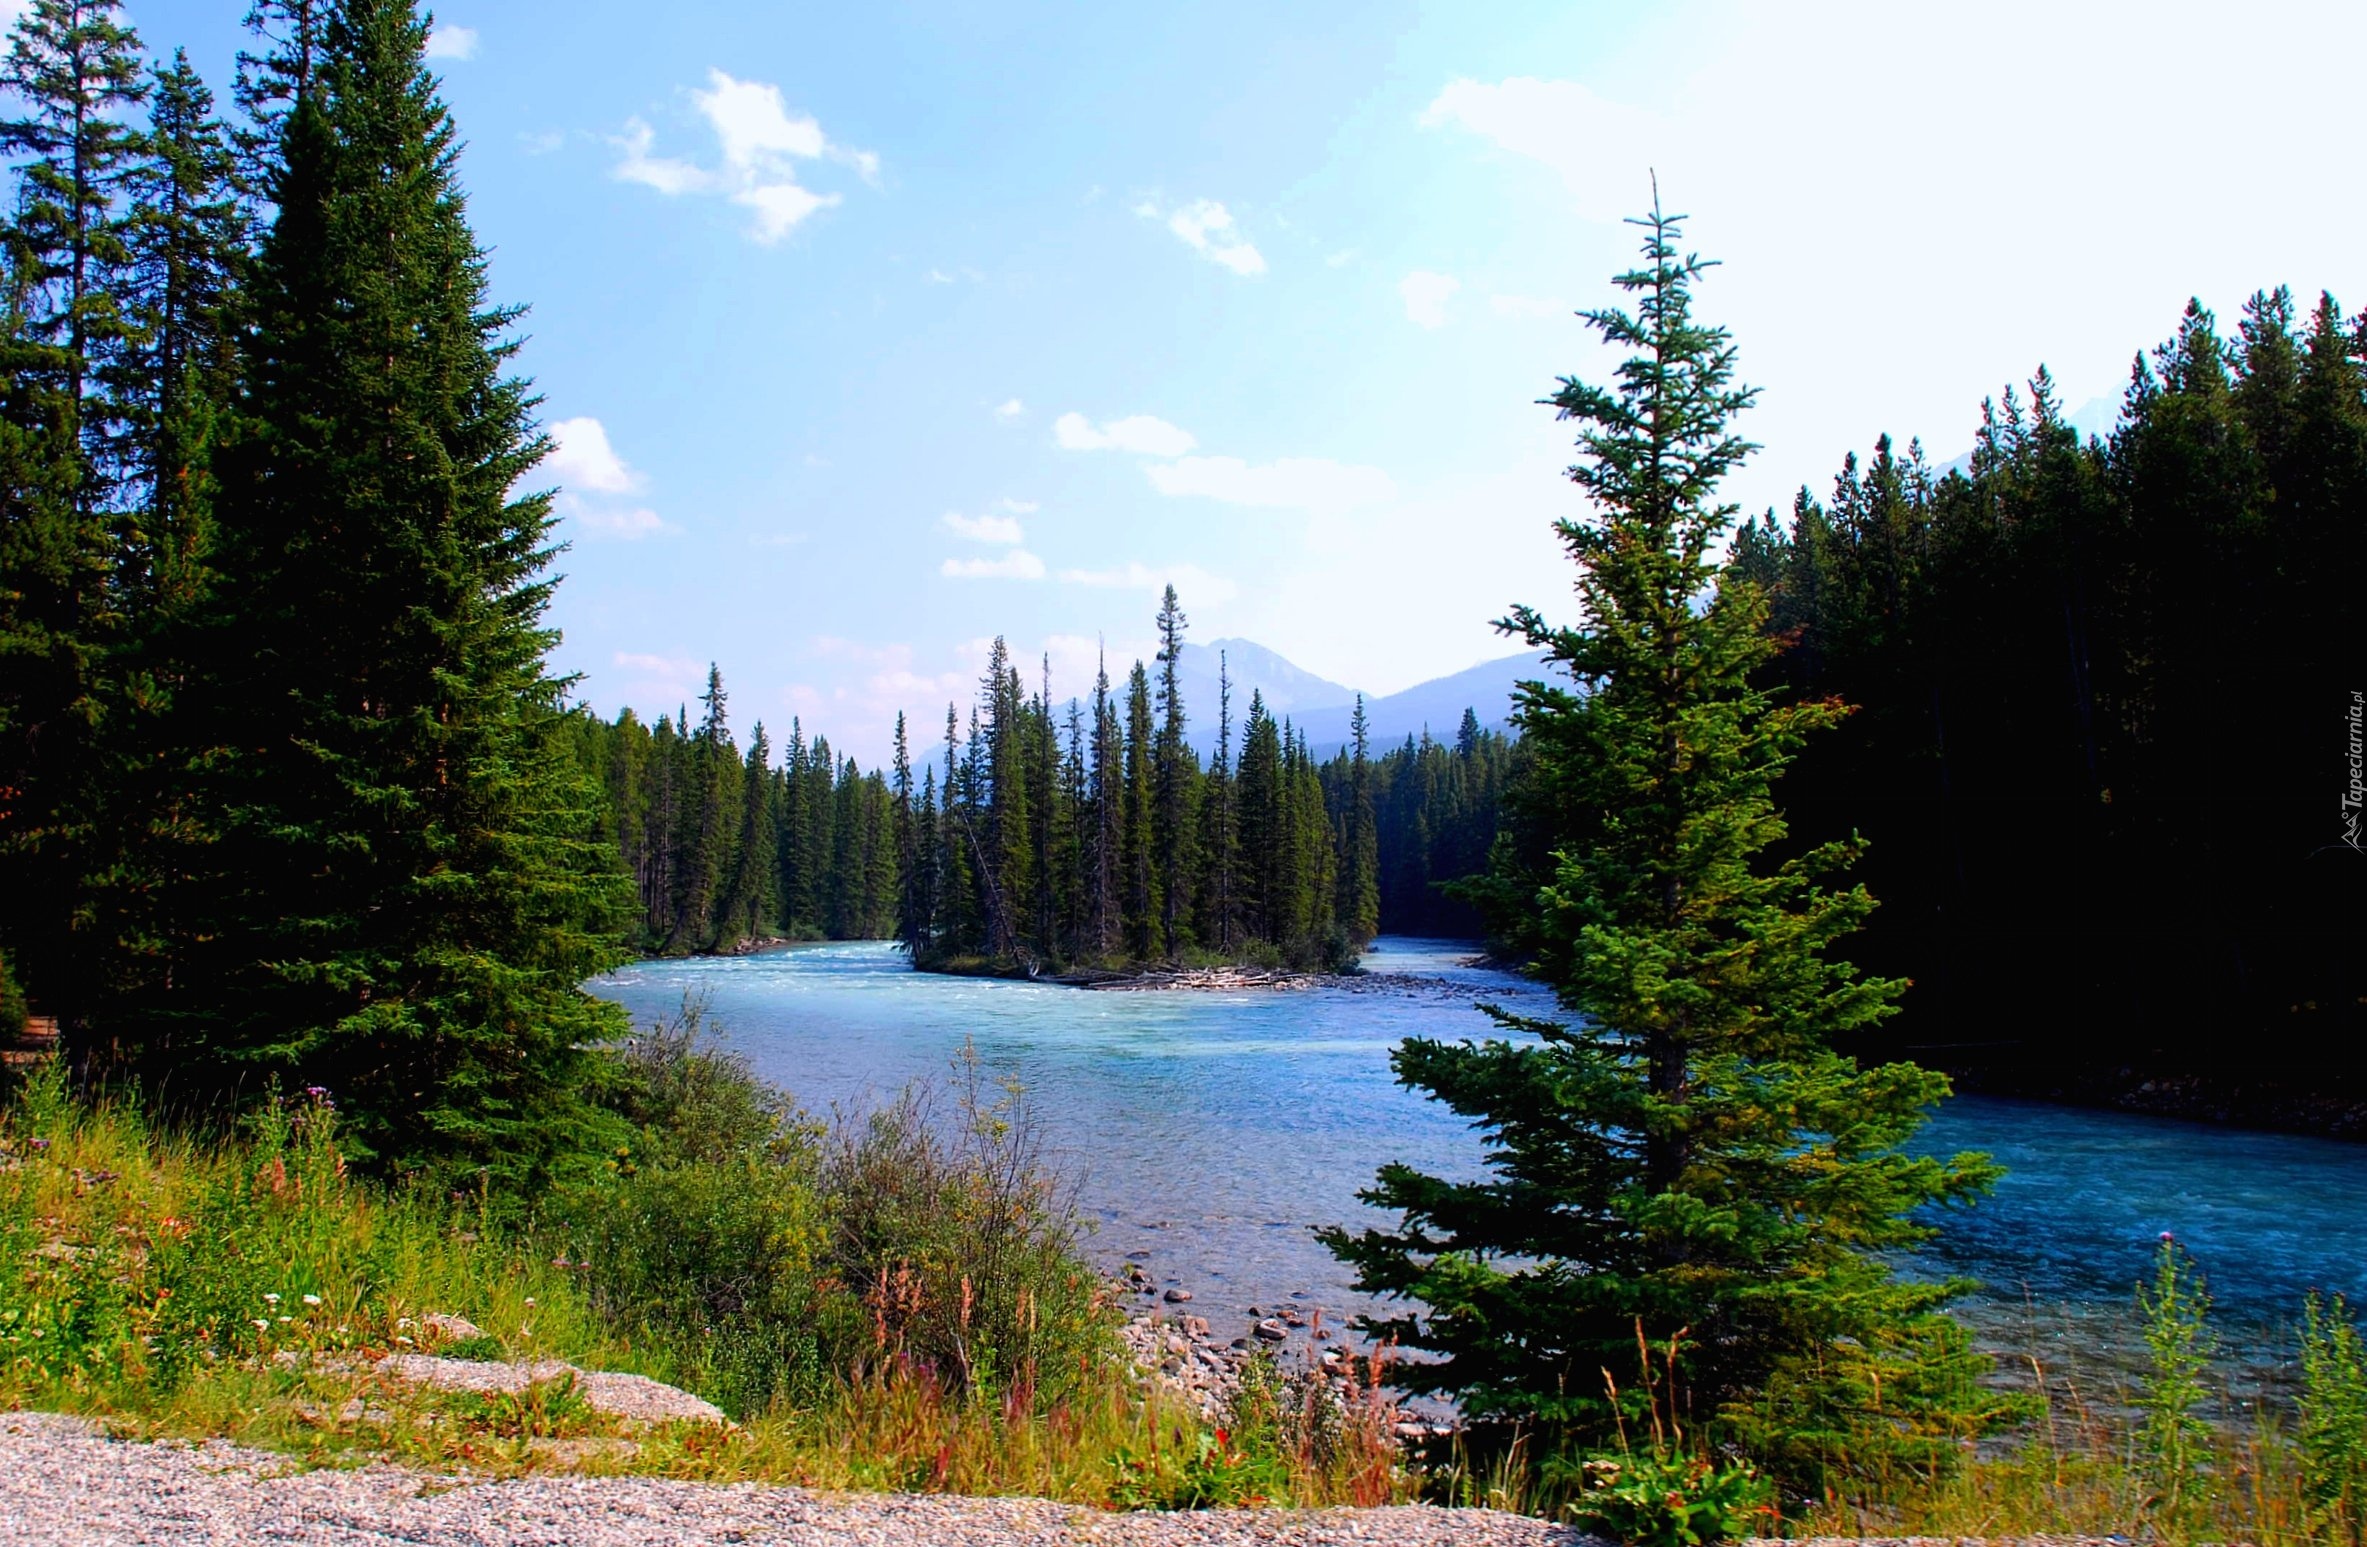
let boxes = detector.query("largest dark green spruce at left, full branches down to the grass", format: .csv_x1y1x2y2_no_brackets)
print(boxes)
164,0,623,1185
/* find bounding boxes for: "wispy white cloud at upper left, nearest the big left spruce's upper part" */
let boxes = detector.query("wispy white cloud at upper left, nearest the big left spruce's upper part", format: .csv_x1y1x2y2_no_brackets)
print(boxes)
615,71,881,244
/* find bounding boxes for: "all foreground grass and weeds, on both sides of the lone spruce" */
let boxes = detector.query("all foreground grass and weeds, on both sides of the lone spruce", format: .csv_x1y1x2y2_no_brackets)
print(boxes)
0,1031,2367,1547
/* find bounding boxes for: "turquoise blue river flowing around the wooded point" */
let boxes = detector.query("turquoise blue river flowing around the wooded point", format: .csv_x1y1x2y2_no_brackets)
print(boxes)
594,937,2367,1374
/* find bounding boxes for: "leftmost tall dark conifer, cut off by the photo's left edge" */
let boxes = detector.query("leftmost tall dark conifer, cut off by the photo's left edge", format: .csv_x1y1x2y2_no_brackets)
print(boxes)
0,0,144,1031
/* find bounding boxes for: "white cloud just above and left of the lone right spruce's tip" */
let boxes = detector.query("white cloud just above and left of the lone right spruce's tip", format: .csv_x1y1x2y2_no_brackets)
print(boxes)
1420,76,1666,220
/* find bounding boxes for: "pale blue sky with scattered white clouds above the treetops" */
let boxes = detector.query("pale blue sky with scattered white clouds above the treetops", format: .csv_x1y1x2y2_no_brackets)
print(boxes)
106,0,2367,762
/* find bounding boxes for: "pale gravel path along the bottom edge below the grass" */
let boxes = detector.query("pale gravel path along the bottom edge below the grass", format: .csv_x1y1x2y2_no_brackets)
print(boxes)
0,1412,1588,1547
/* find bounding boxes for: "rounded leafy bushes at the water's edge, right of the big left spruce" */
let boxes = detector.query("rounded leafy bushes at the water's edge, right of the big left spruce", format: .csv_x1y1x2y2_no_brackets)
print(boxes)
547,1001,1110,1417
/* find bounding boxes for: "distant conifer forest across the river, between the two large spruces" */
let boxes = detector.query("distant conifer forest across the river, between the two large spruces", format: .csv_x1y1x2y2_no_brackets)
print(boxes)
570,629,1517,970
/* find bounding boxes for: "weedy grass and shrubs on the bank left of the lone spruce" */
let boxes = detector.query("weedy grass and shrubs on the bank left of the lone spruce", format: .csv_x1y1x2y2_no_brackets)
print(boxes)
0,1031,1411,1507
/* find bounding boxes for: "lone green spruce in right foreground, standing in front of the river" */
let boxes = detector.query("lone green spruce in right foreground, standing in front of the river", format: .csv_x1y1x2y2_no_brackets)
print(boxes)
1326,197,1995,1485
